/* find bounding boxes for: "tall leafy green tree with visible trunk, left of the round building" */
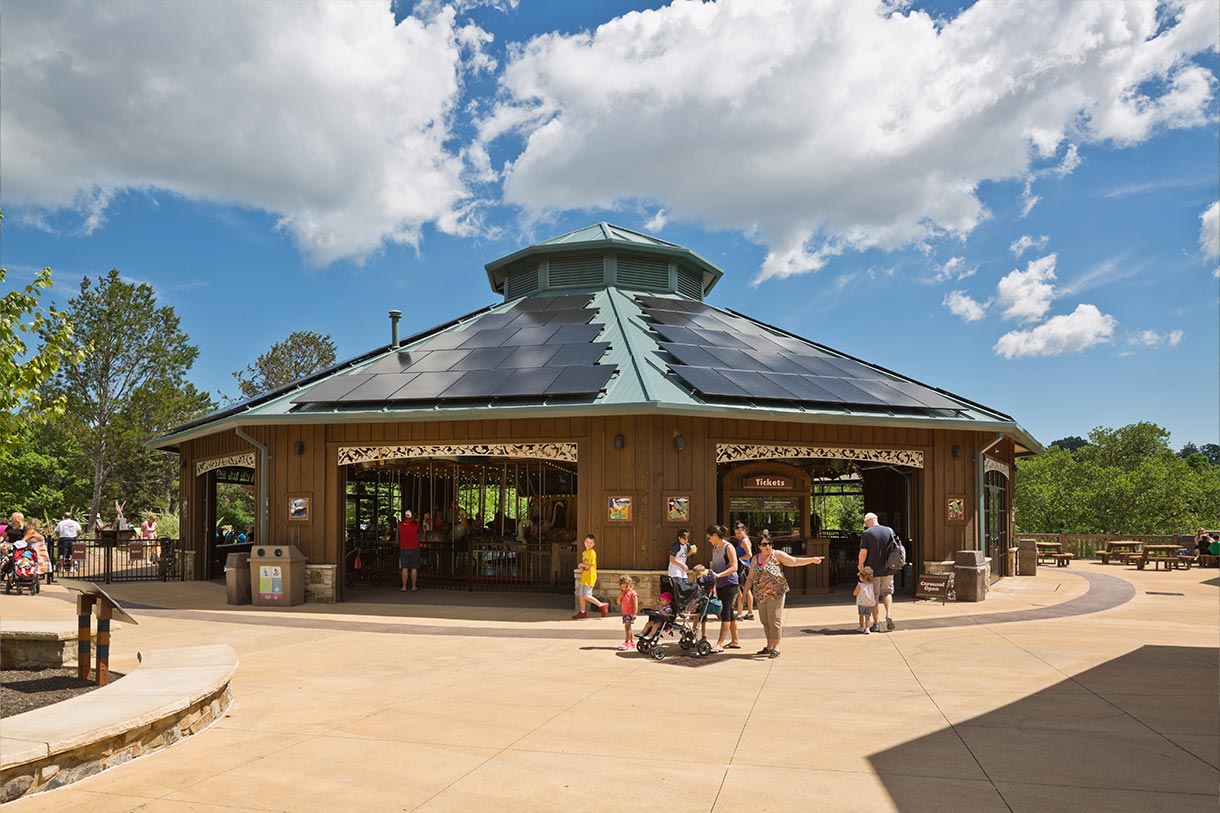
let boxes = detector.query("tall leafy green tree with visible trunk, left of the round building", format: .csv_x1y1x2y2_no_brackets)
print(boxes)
49,269,212,522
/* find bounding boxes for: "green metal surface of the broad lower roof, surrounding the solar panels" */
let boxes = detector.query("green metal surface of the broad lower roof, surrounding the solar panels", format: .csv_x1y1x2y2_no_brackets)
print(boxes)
151,281,1042,452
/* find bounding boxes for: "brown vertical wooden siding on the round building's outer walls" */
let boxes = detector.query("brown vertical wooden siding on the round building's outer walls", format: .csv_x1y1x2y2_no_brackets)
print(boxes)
182,415,1015,578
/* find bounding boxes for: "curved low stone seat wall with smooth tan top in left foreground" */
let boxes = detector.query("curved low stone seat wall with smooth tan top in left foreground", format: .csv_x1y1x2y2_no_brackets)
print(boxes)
0,643,238,804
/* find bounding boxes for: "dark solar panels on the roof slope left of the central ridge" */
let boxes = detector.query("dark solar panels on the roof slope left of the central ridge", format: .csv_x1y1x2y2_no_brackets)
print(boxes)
293,294,616,404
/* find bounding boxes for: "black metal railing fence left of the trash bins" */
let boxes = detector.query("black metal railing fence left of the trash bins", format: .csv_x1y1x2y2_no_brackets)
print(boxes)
54,537,185,585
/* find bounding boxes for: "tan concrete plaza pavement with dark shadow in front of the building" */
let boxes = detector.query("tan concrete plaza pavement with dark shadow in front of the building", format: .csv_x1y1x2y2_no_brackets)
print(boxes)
0,563,1220,813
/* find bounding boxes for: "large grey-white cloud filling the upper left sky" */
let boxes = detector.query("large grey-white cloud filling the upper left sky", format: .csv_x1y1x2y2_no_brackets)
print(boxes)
0,0,494,264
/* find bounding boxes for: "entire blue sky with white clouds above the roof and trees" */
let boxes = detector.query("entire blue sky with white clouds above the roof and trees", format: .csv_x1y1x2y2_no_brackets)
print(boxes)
7,0,1220,444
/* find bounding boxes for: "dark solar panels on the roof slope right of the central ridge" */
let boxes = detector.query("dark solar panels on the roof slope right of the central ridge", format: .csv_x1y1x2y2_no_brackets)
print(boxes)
636,295,961,409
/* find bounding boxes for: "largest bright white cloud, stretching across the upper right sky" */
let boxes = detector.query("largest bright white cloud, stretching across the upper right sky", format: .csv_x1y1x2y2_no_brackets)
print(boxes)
471,0,1220,280
